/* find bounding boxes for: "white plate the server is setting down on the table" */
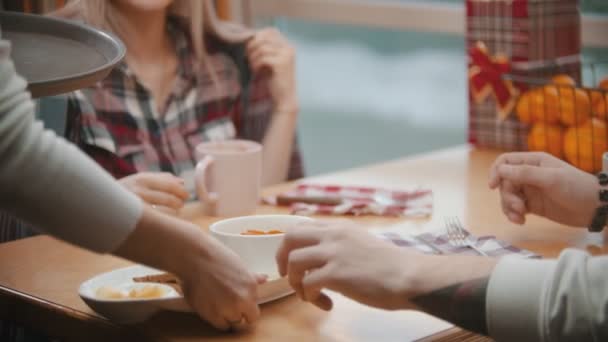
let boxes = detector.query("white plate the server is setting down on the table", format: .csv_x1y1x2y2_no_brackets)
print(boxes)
78,265,294,324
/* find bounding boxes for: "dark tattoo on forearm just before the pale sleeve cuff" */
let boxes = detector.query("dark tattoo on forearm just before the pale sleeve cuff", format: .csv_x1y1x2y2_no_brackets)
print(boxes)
411,278,489,335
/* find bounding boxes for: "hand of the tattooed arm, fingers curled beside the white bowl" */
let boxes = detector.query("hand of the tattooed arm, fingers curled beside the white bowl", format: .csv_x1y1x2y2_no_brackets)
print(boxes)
276,222,416,310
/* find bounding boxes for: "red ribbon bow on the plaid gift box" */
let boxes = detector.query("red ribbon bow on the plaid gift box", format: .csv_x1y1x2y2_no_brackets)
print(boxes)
469,42,519,120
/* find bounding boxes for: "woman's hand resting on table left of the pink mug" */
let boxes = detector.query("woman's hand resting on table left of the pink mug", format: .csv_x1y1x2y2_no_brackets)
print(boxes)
119,172,190,214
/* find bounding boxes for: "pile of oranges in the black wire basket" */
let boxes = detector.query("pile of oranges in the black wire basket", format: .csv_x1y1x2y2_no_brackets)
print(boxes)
515,74,608,172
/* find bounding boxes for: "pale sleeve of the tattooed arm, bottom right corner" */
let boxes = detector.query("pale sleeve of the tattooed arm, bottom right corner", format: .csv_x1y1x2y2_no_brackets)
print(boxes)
486,249,608,341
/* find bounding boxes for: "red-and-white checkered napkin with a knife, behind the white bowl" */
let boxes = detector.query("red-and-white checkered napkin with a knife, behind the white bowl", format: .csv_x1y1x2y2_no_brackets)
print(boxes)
264,184,433,217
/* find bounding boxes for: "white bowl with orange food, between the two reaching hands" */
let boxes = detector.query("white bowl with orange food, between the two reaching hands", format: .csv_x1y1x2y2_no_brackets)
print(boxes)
209,215,313,279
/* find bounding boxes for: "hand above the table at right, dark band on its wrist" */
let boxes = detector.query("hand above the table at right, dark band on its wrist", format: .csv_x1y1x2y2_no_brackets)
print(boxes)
489,152,600,227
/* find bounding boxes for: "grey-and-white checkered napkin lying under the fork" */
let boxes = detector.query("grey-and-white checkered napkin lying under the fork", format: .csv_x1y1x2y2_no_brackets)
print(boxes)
373,231,541,258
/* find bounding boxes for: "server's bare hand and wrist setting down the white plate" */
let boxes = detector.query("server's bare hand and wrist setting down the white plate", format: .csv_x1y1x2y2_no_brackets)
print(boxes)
114,207,266,330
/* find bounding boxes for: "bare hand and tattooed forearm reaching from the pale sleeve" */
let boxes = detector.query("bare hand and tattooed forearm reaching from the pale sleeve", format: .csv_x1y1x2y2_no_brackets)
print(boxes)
277,222,496,334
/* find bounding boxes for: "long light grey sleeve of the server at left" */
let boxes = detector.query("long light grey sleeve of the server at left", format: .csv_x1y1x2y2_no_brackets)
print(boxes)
0,40,143,252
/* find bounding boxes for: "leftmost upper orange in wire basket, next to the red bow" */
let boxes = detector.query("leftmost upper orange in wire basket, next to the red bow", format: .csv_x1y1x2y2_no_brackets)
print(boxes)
515,86,559,124
